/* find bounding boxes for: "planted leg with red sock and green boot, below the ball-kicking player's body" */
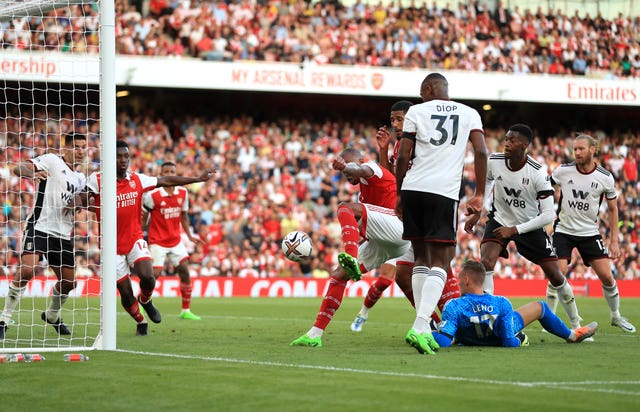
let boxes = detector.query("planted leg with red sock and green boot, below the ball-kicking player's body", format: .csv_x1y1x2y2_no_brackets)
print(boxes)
289,264,352,348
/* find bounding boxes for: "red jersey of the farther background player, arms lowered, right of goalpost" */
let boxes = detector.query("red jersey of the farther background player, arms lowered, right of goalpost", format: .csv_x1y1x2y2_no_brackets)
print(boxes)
144,187,189,248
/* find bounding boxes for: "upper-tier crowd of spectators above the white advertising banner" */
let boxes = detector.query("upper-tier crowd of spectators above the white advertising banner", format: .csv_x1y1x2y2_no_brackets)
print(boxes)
0,0,640,78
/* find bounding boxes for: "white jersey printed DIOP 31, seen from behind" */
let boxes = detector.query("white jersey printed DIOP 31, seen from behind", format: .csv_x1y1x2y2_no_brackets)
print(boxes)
402,100,483,201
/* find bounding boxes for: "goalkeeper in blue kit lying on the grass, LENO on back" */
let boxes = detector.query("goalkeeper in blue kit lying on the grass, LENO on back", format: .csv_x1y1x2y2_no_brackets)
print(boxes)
433,260,598,347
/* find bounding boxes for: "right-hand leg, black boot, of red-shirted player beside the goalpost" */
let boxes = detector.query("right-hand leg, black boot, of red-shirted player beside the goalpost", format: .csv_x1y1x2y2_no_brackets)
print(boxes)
127,239,162,323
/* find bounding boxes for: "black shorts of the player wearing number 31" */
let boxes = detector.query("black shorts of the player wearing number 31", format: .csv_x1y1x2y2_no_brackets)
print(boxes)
401,190,458,245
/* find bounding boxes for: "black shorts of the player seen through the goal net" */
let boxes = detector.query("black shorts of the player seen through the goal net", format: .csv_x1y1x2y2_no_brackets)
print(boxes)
22,226,76,268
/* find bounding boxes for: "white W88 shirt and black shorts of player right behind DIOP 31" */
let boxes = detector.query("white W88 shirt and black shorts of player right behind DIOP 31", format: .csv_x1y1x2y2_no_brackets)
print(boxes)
482,153,557,264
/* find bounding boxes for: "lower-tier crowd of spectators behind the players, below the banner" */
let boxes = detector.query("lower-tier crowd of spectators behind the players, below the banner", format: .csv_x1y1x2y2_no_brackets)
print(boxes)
0,111,640,279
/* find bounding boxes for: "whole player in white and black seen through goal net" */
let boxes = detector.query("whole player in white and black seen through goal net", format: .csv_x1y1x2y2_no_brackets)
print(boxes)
0,133,87,339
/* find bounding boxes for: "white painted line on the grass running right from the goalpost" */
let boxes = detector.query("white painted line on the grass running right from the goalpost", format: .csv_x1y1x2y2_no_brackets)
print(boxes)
116,349,640,396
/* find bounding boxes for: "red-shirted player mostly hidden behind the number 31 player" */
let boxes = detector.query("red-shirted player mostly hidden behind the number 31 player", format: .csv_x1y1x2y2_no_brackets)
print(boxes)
351,100,460,332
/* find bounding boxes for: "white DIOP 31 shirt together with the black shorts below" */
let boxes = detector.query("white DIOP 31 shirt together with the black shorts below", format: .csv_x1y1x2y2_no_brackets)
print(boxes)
401,100,483,245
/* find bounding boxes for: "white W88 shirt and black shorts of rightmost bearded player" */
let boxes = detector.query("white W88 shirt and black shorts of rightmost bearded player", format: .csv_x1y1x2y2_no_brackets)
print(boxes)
551,162,617,265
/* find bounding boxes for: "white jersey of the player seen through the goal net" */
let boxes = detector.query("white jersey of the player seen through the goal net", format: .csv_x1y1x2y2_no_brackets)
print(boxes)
27,154,86,240
